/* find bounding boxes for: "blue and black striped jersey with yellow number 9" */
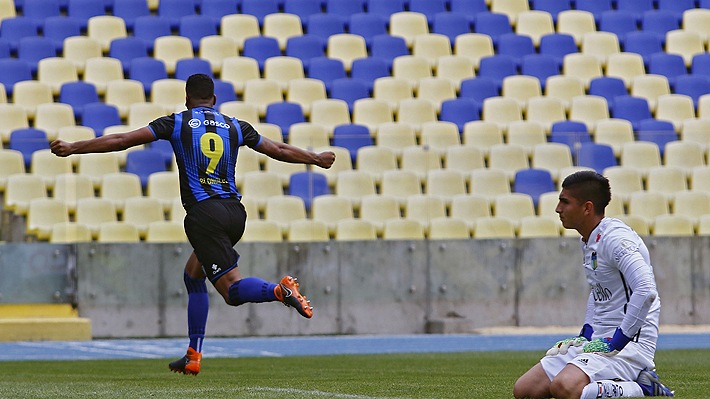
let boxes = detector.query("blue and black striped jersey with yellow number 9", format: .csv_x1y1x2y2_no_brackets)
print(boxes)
148,107,261,209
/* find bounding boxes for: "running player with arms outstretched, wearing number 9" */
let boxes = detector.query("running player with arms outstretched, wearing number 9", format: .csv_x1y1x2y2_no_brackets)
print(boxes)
50,74,335,375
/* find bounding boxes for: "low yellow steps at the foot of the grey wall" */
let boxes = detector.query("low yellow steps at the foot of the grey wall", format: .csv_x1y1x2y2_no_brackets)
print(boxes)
0,304,91,342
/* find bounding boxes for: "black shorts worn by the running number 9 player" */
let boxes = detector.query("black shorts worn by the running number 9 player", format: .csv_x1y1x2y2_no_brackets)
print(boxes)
185,198,247,283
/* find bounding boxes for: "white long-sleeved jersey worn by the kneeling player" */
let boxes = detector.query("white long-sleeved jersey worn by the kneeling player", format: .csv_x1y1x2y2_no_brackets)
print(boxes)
580,217,661,351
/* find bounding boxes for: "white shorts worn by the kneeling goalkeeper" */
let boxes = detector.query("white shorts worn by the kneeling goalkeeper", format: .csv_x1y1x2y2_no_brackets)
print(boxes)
540,342,655,382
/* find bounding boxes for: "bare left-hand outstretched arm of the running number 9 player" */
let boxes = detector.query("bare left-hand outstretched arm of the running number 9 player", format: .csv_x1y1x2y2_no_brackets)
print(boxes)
49,127,156,157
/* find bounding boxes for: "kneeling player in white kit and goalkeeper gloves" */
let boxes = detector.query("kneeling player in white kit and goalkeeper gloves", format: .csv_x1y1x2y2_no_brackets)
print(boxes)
513,171,673,399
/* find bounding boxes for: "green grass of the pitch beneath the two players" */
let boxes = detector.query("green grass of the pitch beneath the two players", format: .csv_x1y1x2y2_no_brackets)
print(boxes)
0,350,710,399
